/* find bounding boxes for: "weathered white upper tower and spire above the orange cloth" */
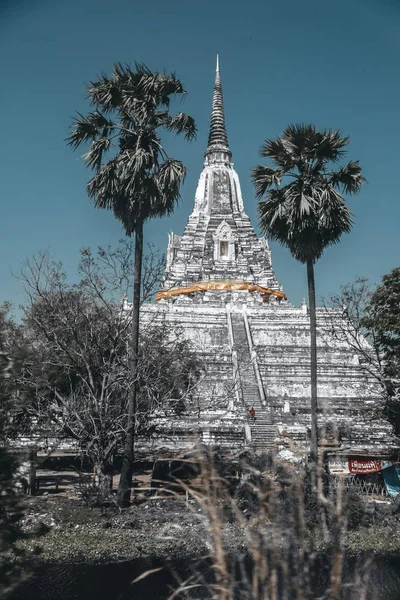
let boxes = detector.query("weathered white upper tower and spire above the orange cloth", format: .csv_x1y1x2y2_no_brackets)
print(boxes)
162,58,280,301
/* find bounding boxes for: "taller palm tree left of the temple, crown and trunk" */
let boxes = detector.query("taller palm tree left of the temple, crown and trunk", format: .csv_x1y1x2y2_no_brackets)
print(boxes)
67,63,196,506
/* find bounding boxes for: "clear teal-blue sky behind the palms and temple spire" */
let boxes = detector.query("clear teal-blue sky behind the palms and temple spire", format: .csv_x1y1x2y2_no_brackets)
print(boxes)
0,0,400,305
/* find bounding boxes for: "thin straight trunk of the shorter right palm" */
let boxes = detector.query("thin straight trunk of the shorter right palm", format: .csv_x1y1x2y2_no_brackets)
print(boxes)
307,260,318,473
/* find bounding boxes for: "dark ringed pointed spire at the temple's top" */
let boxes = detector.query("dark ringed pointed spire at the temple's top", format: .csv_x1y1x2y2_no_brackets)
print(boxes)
206,54,232,162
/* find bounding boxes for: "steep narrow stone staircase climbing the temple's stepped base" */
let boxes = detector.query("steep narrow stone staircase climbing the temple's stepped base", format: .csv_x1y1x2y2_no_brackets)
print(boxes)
231,313,276,450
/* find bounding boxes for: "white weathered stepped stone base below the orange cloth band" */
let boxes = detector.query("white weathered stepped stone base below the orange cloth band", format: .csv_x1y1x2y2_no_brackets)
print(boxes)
142,300,395,452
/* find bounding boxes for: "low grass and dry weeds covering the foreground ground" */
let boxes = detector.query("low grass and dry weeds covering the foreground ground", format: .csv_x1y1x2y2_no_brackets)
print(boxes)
7,449,400,600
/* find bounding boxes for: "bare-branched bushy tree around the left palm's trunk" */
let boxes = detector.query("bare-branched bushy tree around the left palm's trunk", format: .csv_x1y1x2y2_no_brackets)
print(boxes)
12,243,201,497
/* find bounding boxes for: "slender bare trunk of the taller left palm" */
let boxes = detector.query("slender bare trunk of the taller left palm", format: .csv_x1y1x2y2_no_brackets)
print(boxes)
118,222,143,506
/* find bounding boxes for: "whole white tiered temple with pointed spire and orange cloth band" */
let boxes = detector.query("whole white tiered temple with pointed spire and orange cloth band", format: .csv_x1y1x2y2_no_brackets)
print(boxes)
142,60,393,456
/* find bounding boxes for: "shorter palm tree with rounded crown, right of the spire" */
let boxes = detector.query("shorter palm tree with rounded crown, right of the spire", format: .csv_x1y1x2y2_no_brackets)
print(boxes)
252,125,365,465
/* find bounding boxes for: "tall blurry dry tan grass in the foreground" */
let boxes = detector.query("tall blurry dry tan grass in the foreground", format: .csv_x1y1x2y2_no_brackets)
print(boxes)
157,454,367,600
